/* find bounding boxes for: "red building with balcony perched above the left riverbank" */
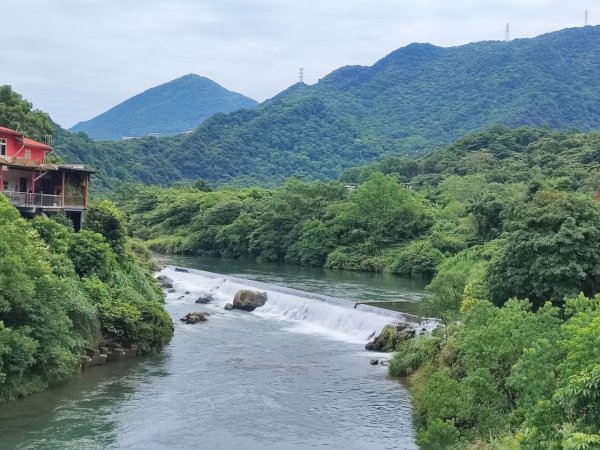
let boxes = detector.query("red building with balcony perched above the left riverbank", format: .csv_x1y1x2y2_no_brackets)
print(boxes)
0,127,95,230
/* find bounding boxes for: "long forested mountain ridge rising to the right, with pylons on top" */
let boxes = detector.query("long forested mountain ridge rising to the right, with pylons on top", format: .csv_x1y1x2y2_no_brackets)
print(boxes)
48,26,600,187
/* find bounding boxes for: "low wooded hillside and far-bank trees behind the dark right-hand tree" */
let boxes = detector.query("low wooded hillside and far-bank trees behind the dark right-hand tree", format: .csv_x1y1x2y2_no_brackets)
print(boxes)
119,126,600,274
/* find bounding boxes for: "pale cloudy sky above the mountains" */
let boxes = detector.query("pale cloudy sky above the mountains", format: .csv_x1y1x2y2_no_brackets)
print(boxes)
0,0,600,128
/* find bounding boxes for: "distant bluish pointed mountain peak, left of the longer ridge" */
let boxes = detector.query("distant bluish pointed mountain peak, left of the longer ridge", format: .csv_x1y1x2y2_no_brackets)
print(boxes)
71,74,257,140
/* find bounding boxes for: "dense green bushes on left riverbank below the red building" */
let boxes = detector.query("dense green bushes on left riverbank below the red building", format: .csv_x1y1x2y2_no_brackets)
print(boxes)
0,196,172,402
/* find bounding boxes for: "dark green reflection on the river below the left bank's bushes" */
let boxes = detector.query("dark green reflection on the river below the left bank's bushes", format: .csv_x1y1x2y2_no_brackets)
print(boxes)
0,353,168,450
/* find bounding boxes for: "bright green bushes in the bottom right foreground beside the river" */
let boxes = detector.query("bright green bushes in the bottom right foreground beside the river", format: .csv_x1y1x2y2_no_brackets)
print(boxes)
390,294,600,450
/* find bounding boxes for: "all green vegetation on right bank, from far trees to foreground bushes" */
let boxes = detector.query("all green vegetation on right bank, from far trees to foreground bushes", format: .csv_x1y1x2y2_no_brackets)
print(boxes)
119,127,600,449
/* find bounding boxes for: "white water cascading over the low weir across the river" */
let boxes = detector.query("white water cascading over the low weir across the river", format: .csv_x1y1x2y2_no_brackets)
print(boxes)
162,266,428,343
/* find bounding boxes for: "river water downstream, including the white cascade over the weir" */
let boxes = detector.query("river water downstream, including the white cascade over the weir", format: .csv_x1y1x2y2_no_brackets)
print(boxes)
0,264,424,450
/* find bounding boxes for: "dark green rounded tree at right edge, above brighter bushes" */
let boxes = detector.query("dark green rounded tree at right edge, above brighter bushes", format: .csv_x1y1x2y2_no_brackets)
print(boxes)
487,191,600,307
